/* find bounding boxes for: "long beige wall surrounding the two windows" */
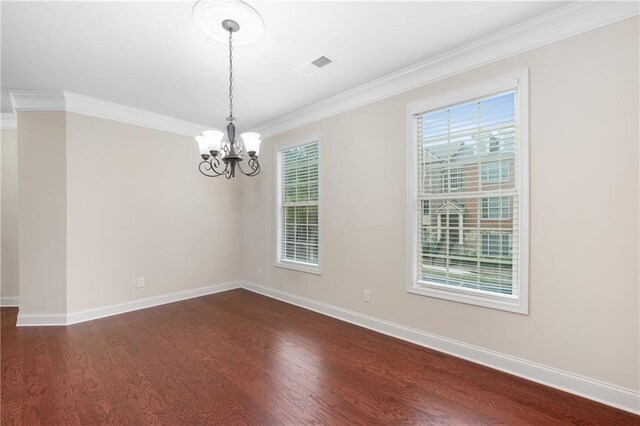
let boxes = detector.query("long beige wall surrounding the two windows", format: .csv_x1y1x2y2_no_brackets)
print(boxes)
243,17,640,390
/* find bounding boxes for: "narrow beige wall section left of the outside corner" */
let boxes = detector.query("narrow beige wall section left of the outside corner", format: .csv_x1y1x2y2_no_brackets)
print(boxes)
18,112,67,314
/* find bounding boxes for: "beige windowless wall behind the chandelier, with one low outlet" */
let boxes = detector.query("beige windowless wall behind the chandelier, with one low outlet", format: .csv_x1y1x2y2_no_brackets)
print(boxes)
66,113,242,313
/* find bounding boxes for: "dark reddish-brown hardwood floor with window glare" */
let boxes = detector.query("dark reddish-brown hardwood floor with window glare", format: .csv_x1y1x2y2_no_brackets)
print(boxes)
0,290,640,425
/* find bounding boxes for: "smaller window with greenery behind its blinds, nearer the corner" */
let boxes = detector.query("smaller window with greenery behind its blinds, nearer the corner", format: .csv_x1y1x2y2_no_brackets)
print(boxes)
276,138,320,272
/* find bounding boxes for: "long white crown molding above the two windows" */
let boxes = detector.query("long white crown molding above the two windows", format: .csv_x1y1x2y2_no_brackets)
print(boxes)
256,1,639,138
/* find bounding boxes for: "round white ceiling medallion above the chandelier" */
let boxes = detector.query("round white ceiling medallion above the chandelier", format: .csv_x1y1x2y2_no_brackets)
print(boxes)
193,0,264,46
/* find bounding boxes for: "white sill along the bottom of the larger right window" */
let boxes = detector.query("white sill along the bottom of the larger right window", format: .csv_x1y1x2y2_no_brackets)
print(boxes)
407,283,529,315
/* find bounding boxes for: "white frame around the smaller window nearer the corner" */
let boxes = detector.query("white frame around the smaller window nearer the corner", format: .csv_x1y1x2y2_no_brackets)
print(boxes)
274,134,323,275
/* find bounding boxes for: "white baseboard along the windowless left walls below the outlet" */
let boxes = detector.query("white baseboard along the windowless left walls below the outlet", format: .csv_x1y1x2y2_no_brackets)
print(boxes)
16,281,241,327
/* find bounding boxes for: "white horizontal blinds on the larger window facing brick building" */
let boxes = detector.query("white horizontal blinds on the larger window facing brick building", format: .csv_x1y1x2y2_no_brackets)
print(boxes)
414,90,519,296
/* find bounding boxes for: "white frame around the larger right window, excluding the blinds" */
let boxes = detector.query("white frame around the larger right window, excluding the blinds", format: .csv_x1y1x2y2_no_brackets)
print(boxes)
406,69,529,315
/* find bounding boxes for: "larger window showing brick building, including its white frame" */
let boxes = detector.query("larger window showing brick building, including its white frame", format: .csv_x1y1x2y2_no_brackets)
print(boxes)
408,71,528,314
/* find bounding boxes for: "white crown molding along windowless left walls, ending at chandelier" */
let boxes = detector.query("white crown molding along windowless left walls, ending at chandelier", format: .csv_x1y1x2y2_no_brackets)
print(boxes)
9,90,210,136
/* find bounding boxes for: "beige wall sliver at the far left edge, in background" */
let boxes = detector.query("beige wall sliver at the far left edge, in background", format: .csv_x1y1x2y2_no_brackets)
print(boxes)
0,129,20,297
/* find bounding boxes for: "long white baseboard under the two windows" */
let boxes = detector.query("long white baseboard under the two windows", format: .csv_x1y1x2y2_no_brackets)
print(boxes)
242,281,640,414
